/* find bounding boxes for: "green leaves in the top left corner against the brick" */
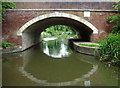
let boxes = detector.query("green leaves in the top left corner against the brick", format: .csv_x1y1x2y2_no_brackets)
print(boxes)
2,2,16,20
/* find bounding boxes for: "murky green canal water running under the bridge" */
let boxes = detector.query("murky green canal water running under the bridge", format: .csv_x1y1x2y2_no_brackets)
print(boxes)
2,37,118,86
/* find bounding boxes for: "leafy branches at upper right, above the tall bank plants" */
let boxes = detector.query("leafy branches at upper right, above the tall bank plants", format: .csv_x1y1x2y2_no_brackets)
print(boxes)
107,0,120,33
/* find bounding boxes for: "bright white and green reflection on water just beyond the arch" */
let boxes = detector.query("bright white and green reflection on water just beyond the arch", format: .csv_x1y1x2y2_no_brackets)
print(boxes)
43,37,70,58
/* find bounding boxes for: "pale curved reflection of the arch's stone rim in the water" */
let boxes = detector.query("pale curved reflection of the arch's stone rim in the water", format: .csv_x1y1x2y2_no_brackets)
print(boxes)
19,65,98,86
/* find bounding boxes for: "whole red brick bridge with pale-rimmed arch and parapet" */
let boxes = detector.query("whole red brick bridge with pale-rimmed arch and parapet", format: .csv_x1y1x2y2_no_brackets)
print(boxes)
2,2,116,50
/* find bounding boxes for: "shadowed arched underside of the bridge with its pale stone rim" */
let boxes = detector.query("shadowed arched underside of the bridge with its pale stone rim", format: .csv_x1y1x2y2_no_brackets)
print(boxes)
17,12,98,50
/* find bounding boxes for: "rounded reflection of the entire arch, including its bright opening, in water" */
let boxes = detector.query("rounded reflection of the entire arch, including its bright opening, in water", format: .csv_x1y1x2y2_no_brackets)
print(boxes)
19,35,98,86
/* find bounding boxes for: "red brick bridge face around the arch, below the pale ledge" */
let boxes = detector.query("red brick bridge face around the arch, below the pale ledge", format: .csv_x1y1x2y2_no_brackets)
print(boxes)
2,11,114,45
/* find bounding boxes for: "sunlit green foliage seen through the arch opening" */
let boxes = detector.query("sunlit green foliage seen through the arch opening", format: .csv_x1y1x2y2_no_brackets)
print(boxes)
41,25,77,38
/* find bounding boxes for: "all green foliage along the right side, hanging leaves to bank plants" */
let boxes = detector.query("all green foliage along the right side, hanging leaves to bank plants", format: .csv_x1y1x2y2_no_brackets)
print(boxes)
95,0,120,66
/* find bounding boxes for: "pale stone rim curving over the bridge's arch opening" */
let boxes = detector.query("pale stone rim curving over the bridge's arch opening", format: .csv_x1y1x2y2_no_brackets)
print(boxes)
17,12,98,36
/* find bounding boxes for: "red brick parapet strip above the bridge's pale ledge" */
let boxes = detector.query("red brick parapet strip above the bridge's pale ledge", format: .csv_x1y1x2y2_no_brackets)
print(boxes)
16,2,115,10
